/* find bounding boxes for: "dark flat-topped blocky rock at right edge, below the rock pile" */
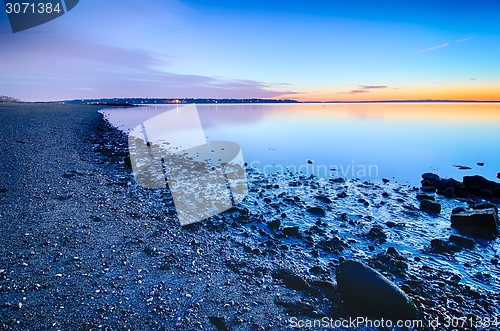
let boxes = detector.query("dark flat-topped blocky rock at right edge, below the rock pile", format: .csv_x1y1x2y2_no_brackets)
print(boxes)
451,208,498,234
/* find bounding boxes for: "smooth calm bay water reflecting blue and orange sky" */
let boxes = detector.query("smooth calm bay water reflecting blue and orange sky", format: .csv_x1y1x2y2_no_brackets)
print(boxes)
98,103,500,185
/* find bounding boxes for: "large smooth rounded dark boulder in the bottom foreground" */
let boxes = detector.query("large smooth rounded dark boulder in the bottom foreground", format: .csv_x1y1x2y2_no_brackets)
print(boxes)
336,260,418,319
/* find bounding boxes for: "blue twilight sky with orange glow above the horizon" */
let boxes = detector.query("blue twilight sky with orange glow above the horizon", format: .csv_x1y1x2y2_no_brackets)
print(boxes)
0,0,500,101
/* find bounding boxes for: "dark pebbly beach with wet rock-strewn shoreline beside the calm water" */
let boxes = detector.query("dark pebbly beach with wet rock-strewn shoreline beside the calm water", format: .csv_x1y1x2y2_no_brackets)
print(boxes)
0,104,500,330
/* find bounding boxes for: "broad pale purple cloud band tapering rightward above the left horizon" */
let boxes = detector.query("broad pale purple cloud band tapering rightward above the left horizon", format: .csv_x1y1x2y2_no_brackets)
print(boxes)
0,34,297,101
